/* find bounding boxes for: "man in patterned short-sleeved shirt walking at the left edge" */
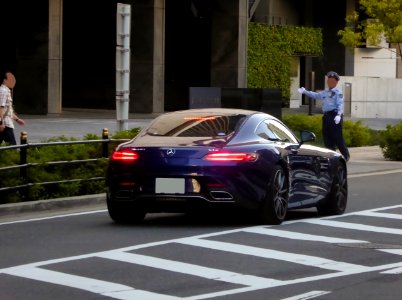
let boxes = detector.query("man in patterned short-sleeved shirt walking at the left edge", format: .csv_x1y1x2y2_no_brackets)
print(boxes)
0,71,25,145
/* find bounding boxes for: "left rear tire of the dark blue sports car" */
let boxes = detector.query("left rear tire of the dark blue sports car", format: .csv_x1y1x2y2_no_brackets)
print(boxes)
107,197,146,224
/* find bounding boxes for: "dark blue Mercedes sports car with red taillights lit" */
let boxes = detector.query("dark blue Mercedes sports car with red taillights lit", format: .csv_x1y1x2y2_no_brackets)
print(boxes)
107,108,348,224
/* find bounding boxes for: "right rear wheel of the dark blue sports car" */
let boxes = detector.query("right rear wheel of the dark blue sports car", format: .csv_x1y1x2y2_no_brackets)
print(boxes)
259,166,289,225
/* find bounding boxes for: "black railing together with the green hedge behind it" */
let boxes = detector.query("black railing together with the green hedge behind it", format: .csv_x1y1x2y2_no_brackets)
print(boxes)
0,128,140,204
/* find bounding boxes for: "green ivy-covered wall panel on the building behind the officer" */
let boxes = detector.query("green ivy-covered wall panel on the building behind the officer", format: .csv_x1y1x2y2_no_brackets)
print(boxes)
247,23,322,105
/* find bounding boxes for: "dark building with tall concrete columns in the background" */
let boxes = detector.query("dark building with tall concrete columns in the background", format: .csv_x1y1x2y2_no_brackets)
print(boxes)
0,0,402,119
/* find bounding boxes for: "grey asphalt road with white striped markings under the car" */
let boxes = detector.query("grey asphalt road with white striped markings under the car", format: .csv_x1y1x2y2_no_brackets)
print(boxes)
0,170,402,300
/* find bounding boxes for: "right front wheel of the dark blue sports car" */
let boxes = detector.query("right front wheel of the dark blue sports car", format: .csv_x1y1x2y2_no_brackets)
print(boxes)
317,163,348,215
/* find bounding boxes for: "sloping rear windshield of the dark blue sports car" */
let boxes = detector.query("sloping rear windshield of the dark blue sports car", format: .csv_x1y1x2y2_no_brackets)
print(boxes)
146,114,246,137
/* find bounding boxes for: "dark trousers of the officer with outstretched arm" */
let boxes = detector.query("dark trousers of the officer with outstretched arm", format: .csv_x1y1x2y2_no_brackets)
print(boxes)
322,111,350,160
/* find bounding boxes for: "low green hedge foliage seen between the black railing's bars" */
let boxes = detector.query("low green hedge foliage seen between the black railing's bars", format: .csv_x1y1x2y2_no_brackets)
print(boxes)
0,128,140,203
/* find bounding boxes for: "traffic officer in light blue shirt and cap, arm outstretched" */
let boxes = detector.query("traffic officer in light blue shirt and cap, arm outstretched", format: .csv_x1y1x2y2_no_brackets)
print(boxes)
298,71,350,161
